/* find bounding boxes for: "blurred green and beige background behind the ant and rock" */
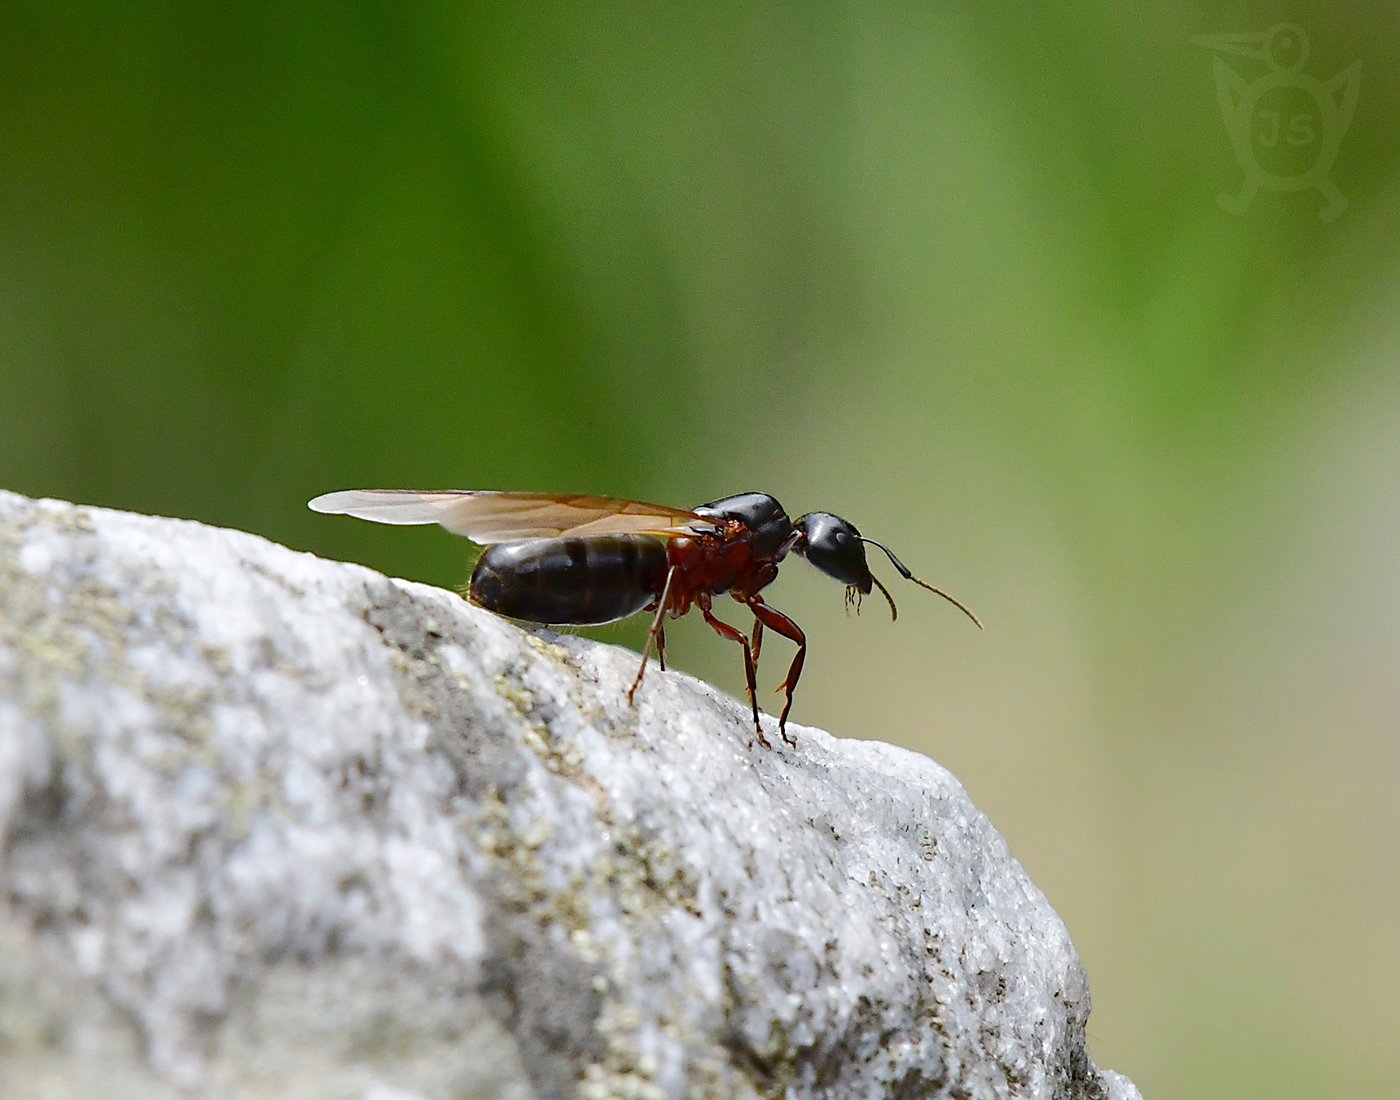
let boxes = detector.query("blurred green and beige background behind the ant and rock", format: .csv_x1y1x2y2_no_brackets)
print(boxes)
0,0,1400,1100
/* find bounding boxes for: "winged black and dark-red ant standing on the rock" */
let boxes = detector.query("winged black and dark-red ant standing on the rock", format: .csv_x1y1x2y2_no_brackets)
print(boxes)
309,488,981,747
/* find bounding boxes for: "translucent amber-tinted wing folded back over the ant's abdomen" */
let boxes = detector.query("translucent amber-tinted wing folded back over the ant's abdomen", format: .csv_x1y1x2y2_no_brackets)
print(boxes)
307,488,714,546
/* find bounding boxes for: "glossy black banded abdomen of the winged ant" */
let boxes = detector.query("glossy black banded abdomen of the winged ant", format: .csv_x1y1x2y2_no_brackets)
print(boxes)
468,535,666,626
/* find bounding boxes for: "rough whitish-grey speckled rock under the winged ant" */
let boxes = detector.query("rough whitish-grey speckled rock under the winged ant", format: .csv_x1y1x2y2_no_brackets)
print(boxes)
0,493,1138,1100
